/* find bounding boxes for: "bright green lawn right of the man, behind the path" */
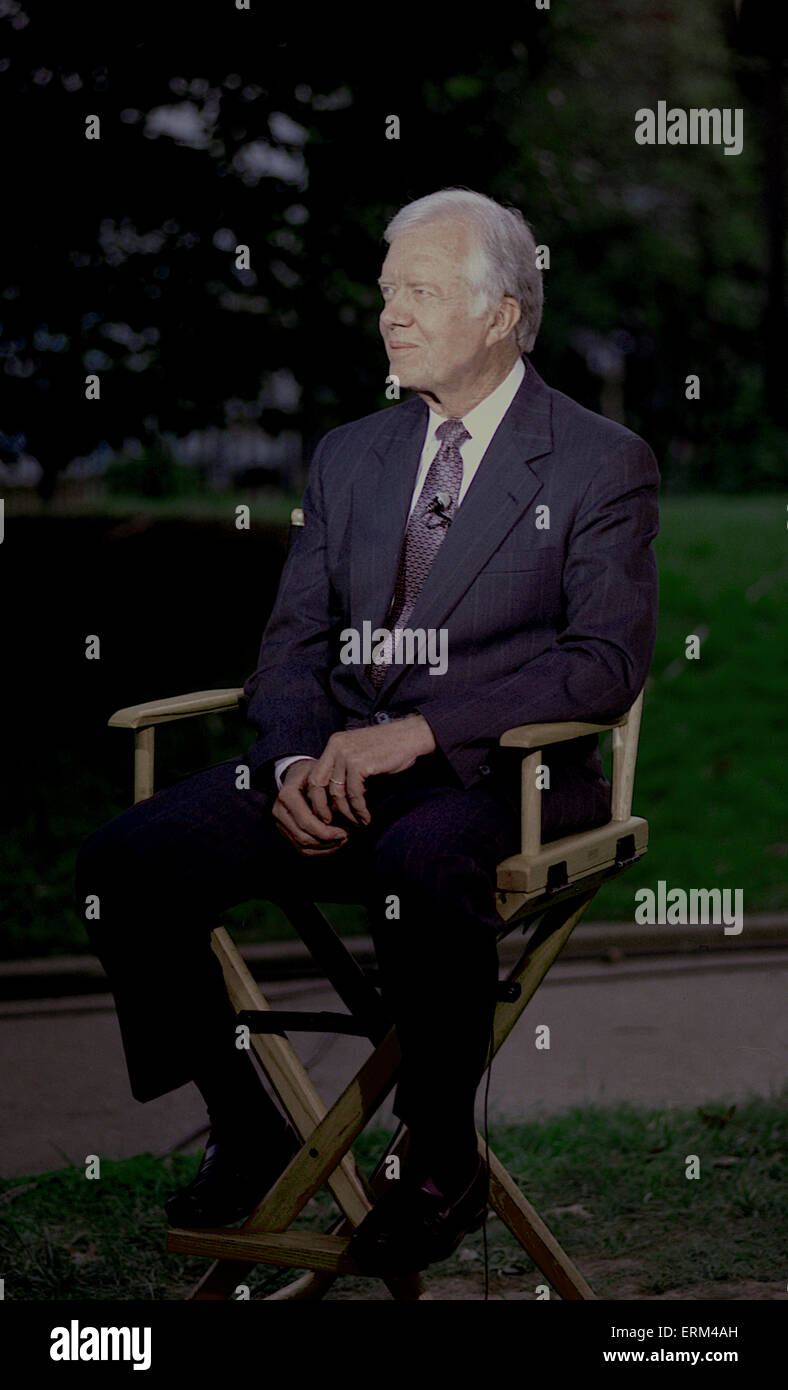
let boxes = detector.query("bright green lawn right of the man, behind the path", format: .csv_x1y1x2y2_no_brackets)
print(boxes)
600,498,788,920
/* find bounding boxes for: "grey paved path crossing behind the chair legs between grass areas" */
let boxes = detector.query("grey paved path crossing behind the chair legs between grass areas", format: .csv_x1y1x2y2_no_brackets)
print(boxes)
0,949,788,1177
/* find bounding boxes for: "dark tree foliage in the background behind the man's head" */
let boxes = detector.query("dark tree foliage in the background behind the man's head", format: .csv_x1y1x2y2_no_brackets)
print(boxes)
0,0,785,493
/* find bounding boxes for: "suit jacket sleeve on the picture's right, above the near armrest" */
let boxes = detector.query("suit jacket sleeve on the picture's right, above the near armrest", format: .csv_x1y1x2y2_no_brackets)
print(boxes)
418,436,659,760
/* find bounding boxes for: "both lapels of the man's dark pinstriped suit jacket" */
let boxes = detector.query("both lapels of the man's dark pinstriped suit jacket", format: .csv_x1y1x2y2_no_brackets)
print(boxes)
378,363,553,694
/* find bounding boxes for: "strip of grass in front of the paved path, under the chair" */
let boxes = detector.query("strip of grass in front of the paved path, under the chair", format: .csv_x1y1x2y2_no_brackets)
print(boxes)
0,1091,788,1300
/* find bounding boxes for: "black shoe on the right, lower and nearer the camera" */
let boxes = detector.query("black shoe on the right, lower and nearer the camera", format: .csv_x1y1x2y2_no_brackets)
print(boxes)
347,1154,489,1275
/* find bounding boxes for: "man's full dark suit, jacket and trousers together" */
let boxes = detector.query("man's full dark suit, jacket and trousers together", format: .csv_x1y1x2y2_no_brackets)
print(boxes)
76,360,659,1123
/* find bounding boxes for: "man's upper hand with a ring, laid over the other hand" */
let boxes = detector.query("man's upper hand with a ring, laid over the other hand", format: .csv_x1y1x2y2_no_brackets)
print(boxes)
305,714,435,826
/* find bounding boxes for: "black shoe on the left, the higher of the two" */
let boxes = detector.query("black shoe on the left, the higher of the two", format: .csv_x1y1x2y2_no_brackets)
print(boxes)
164,1125,302,1226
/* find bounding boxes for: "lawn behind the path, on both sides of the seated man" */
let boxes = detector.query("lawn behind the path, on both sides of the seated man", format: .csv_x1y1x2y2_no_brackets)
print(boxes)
0,495,788,958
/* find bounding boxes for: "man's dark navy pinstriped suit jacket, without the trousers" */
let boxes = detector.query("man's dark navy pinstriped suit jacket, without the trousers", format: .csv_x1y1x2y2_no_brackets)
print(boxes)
245,359,659,819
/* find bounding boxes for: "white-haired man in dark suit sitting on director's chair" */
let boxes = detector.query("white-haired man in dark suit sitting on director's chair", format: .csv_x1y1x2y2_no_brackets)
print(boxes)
78,189,659,1272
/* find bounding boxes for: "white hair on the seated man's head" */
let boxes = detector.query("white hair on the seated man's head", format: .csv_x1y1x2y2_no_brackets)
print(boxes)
384,188,543,352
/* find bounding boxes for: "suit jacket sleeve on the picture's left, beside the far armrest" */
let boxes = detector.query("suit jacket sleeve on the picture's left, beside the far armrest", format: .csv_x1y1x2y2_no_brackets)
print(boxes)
243,436,343,771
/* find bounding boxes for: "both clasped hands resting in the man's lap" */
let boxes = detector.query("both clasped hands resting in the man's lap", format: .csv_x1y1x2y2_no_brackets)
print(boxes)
272,714,435,855
